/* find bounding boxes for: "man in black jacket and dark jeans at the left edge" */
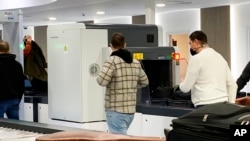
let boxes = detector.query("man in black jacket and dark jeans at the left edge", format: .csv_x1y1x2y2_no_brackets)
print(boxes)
0,40,25,119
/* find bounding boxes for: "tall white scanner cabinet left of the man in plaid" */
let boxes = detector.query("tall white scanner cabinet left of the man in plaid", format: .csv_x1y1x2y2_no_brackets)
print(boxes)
47,24,108,122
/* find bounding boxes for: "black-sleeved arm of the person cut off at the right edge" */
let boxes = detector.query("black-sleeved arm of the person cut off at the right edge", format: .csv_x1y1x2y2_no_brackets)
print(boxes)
237,61,250,92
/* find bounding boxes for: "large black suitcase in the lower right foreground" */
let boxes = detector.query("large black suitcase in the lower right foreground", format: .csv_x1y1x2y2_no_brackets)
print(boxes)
166,102,250,141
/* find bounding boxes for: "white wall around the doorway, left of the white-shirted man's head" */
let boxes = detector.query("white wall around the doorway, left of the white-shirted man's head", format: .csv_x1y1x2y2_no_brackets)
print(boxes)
155,9,200,46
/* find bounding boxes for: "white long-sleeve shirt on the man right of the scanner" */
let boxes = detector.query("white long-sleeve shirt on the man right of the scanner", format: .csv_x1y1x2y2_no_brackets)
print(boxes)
179,47,237,106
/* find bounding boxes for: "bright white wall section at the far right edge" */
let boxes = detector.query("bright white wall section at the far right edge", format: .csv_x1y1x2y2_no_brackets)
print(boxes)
231,3,250,92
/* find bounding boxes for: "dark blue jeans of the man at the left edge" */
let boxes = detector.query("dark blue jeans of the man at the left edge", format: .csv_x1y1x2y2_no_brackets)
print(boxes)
0,99,19,120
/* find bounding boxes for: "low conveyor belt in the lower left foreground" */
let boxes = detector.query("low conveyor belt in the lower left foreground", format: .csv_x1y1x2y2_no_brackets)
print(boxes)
0,119,87,134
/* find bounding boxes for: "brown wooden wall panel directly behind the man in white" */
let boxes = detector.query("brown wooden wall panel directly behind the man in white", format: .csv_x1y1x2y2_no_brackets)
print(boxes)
201,6,231,66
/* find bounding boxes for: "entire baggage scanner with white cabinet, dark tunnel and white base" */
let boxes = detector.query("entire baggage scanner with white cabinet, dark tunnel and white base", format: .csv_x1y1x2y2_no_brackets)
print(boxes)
13,23,193,137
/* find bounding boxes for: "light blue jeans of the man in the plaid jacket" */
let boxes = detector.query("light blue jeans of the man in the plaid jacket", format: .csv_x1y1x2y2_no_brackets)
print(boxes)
106,110,134,135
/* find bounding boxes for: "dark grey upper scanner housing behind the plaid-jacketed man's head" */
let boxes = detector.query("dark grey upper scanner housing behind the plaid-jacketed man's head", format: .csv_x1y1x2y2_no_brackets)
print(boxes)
85,23,163,47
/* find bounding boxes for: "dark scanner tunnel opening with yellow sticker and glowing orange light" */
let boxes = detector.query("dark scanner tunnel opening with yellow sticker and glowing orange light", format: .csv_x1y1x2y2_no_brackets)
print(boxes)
127,46,192,108
